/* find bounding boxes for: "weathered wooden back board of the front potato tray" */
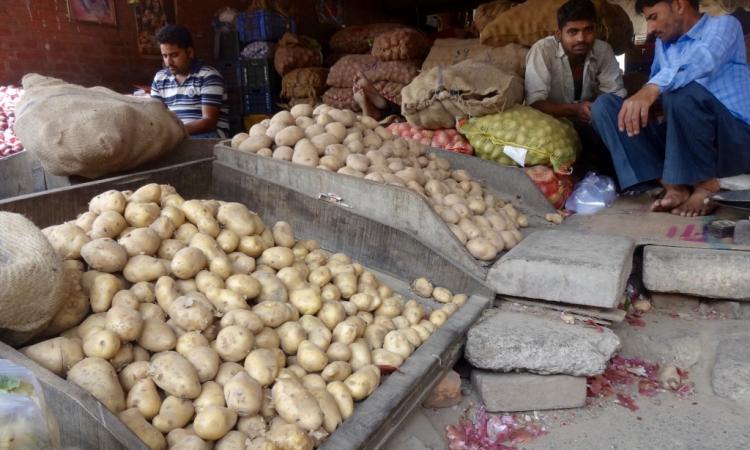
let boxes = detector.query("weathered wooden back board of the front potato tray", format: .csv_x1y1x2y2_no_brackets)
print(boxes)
212,160,489,292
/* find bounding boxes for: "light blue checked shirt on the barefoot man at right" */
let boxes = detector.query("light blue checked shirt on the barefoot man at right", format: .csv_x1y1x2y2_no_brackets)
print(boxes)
649,14,750,124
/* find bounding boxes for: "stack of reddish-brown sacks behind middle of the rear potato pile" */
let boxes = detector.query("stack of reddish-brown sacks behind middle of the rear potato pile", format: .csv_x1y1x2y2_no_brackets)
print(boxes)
323,24,430,111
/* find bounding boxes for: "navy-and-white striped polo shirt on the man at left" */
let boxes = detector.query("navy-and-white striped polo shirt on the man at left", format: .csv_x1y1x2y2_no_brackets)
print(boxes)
151,60,229,137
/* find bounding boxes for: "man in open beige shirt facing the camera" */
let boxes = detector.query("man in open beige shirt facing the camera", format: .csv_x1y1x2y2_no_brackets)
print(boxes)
526,0,626,175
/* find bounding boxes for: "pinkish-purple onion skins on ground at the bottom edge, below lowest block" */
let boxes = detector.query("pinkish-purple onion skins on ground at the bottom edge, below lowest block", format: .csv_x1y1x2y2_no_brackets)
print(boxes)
446,407,547,450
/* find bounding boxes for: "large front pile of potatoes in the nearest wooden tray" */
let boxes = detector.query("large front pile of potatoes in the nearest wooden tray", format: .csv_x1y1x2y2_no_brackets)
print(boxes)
21,184,466,450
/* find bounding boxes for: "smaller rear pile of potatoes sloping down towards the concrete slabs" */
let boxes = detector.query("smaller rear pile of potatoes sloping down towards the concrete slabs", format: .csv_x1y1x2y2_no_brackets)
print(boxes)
231,105,529,261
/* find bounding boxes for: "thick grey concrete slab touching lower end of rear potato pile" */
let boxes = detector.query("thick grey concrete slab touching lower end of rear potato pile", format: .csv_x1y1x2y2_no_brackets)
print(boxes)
487,230,635,308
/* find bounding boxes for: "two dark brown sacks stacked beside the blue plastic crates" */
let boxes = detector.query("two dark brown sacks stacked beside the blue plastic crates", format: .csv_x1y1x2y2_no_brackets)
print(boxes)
273,33,328,105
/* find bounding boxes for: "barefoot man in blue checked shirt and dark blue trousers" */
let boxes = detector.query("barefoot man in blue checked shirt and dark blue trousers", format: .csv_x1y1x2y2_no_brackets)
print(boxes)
592,0,750,217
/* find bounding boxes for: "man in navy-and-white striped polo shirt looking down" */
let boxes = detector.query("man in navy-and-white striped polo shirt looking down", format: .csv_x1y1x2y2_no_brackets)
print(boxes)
151,25,229,139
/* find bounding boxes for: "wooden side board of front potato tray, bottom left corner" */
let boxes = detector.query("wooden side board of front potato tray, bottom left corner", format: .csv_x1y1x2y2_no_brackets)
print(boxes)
0,342,148,450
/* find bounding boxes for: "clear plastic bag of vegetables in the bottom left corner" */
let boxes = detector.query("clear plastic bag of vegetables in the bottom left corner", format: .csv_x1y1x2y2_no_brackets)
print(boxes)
0,359,60,450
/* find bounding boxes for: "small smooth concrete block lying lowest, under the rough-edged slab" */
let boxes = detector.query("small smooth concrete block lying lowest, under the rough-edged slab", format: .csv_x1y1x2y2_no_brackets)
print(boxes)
471,370,586,412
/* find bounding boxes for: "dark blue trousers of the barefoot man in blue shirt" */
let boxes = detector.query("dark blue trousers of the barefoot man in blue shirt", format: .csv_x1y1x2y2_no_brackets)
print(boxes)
591,82,750,189
